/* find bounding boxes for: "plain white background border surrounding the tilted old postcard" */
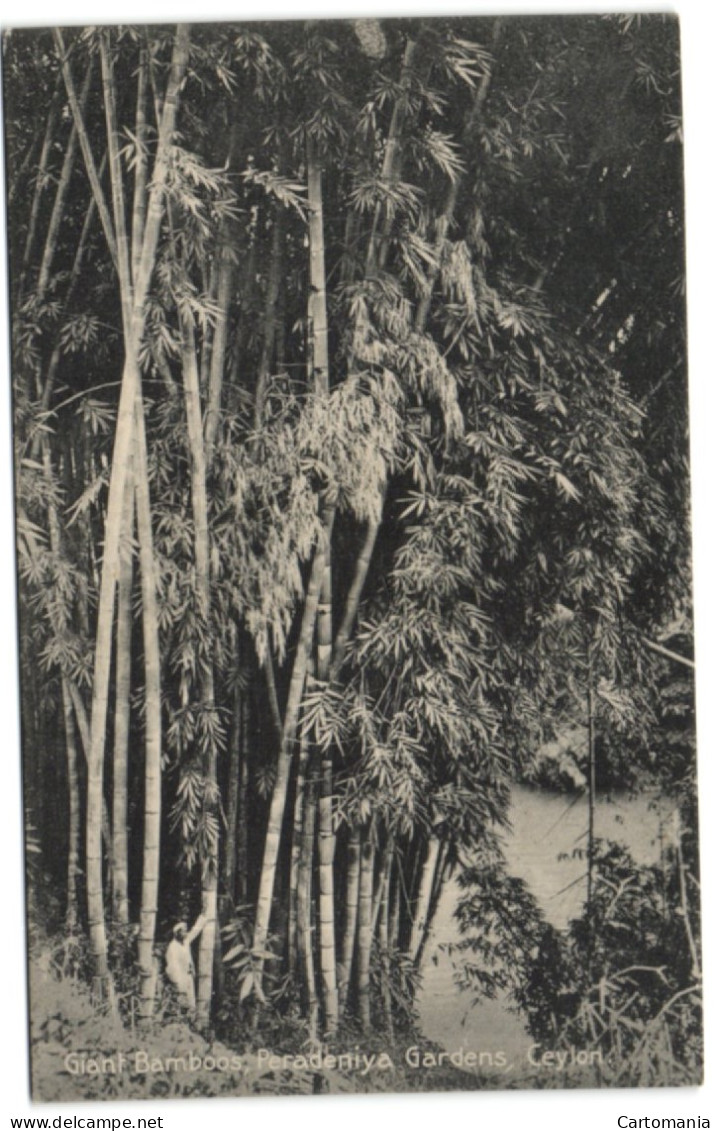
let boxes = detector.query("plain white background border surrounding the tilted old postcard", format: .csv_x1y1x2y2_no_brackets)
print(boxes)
0,0,721,1131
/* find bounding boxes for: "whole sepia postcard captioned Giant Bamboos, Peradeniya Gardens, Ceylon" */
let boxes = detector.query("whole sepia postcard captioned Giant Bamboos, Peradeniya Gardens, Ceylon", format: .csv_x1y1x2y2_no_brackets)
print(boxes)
2,6,710,1126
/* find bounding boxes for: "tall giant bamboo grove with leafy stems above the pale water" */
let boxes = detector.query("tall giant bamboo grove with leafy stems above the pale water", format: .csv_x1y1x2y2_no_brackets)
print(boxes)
3,17,690,1054
